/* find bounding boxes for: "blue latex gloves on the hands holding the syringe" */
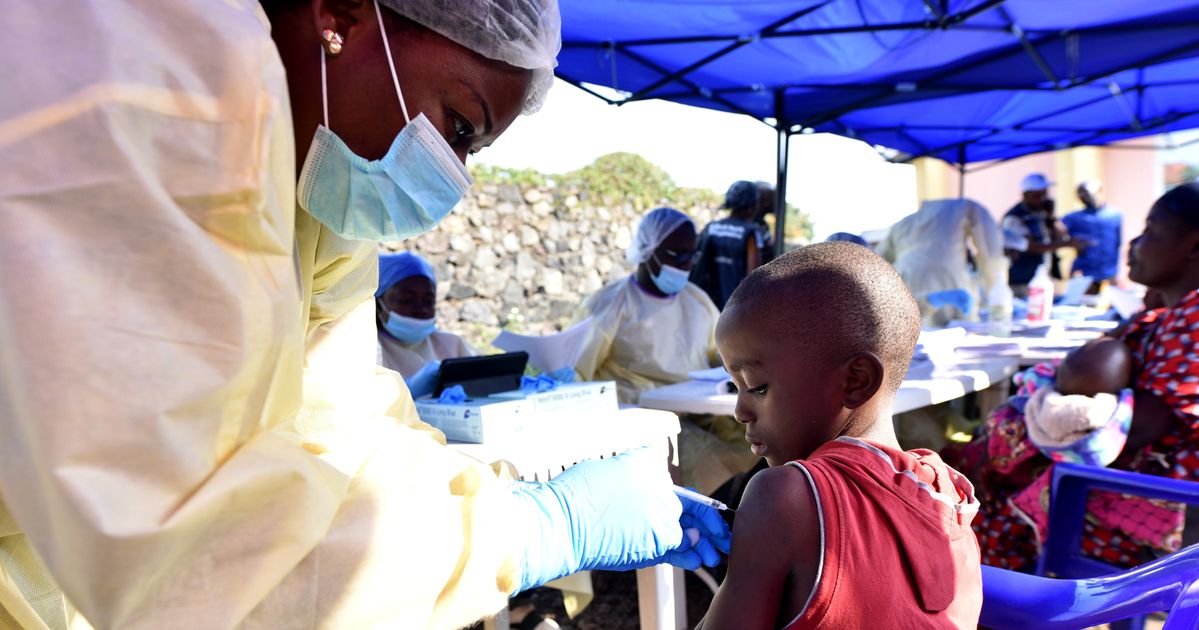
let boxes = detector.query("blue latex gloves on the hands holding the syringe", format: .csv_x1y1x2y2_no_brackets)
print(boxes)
512,449,730,592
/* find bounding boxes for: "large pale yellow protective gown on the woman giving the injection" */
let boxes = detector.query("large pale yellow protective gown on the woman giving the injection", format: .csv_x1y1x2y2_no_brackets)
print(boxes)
0,0,519,629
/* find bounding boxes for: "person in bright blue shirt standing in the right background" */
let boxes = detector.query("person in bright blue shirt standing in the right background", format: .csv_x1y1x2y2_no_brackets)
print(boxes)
1061,180,1123,293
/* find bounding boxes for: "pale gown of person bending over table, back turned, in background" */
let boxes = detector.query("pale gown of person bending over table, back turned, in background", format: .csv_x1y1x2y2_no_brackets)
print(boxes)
879,199,1007,326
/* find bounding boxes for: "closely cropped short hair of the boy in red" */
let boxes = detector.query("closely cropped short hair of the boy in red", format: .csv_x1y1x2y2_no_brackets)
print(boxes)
725,241,920,392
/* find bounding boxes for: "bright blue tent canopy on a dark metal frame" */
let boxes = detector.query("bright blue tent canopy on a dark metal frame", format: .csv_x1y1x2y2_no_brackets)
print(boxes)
558,0,1199,163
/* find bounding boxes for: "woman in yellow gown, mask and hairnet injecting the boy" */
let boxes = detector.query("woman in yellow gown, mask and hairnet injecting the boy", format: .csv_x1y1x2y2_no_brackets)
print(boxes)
0,0,727,629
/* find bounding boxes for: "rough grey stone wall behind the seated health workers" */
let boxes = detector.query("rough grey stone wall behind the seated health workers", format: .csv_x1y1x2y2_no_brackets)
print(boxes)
382,182,717,353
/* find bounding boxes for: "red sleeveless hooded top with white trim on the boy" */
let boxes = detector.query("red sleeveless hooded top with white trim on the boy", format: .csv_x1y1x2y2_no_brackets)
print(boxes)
785,438,982,630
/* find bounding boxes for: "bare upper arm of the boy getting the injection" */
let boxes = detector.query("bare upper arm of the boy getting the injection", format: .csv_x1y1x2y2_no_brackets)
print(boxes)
697,466,823,630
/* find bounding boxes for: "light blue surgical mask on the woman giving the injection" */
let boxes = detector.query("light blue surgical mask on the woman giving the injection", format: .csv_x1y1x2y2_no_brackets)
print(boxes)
296,4,471,241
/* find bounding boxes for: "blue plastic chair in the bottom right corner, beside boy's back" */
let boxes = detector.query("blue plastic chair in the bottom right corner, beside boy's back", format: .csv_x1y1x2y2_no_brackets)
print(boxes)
978,545,1199,630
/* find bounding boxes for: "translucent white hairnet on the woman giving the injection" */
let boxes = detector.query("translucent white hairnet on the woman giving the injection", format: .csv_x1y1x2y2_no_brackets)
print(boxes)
379,0,562,114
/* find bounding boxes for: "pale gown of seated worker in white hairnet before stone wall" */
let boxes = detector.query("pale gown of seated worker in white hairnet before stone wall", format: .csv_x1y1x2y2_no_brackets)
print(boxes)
574,276,721,403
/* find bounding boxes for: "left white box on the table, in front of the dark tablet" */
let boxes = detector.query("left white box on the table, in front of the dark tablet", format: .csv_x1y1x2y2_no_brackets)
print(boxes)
416,397,536,444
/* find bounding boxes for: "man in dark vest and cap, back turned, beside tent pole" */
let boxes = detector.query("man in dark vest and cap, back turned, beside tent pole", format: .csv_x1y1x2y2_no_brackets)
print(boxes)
691,180,766,308
